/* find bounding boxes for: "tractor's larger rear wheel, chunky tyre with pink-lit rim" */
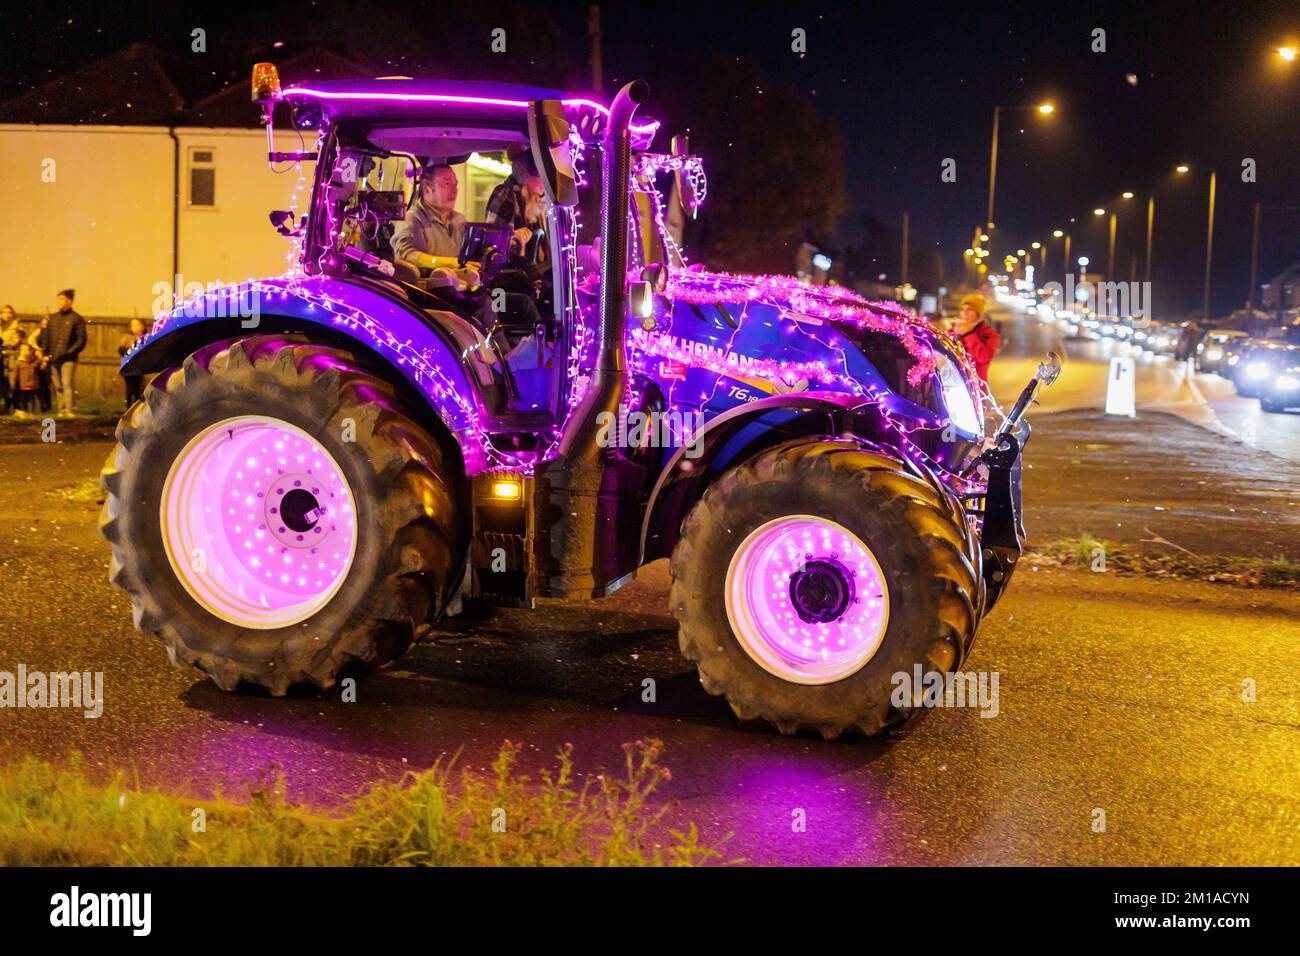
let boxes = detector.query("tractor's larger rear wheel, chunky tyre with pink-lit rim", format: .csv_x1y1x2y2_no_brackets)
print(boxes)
100,336,467,696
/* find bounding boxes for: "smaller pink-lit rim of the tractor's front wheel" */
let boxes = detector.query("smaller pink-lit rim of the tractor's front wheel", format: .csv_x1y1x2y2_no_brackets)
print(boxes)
725,515,889,684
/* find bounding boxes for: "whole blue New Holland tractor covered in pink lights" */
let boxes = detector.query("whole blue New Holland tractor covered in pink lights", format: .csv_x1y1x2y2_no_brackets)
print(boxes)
101,64,1060,739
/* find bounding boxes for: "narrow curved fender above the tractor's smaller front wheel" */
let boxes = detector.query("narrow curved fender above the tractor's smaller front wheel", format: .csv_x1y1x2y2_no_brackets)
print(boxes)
641,392,920,564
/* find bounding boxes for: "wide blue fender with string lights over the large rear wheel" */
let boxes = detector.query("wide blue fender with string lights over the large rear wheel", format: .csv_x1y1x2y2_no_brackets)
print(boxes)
121,277,482,475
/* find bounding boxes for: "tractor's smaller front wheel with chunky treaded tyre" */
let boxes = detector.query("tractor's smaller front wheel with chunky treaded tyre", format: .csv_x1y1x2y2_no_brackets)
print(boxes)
670,441,983,740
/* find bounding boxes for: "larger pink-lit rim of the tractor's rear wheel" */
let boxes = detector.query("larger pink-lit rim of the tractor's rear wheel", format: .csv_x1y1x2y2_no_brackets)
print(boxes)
160,415,356,630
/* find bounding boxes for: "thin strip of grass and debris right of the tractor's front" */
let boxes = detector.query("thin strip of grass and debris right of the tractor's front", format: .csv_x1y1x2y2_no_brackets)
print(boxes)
1026,532,1300,588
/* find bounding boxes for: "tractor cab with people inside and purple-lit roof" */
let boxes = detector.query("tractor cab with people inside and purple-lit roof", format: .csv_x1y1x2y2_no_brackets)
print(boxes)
254,68,655,460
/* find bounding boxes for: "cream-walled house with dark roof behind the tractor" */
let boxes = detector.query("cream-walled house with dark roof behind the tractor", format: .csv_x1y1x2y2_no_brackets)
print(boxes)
0,43,382,395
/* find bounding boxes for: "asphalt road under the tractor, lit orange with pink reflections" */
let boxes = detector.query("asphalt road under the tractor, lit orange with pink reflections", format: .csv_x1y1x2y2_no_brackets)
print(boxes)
0,434,1300,865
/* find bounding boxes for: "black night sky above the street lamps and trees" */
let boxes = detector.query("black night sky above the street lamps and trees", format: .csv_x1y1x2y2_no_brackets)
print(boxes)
0,0,1300,311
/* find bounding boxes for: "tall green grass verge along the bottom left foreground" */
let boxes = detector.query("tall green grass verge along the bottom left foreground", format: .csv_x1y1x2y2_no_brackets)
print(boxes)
0,740,722,866
